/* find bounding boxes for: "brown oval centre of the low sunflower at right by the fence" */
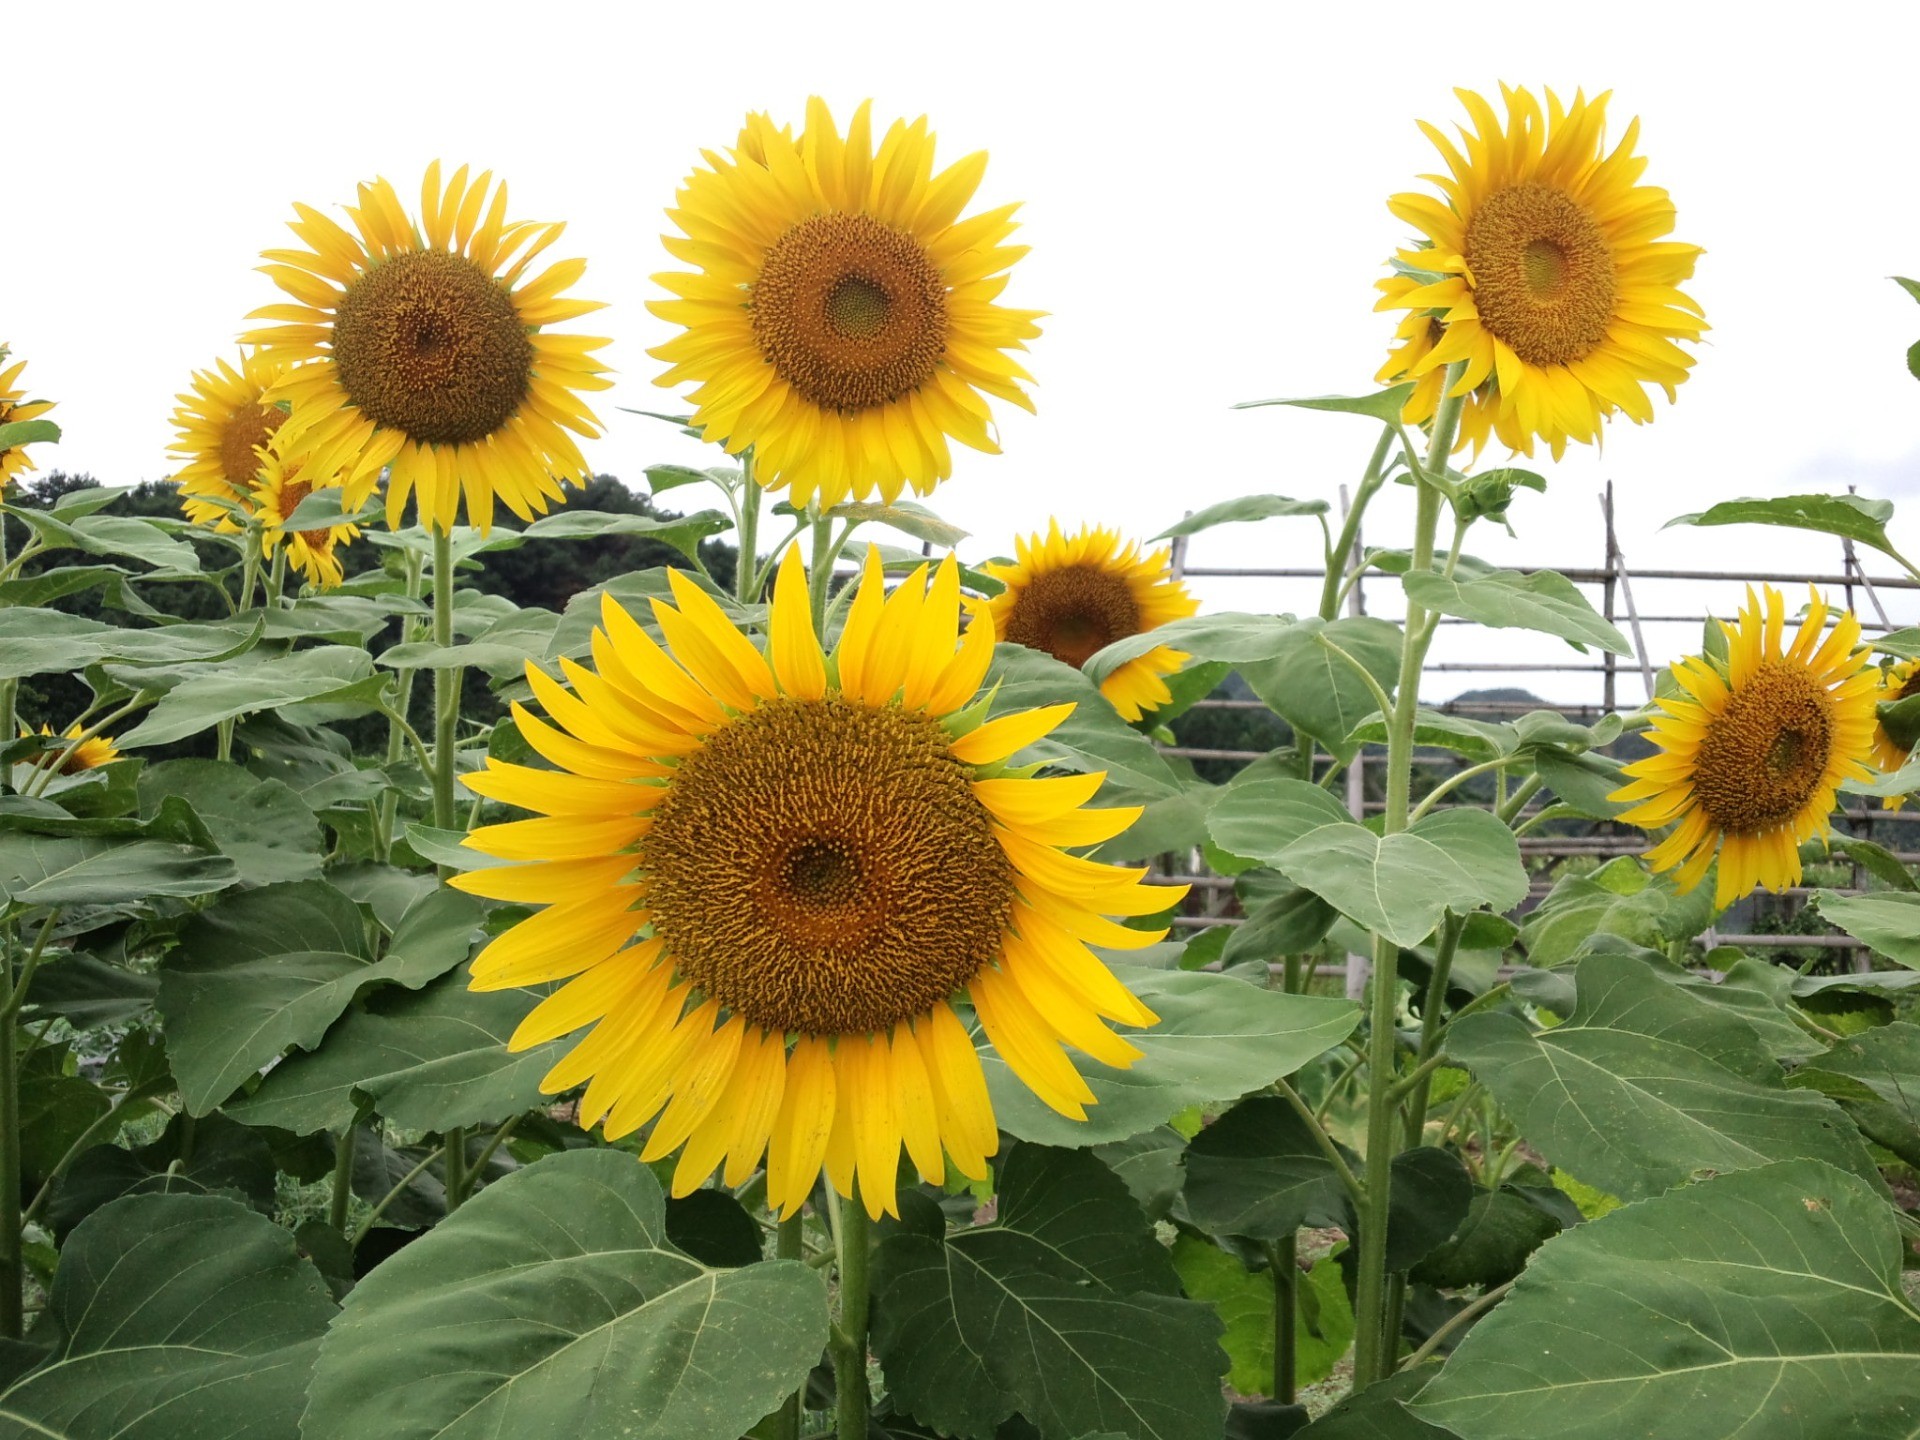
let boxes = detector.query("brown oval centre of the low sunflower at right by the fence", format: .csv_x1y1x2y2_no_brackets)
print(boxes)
1693,660,1834,835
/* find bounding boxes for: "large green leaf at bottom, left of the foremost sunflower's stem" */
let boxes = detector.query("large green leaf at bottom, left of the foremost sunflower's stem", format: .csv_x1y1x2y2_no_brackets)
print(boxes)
301,1150,828,1440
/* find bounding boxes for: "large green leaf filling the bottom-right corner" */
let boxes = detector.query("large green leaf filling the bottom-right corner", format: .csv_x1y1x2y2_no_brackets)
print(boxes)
1413,1160,1920,1440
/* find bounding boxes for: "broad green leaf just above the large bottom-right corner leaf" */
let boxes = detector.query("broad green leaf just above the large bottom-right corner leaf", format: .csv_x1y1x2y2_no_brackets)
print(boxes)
1448,954,1874,1200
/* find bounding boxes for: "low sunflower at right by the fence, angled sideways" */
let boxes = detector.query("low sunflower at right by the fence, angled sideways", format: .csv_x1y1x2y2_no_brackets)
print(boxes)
1613,586,1880,908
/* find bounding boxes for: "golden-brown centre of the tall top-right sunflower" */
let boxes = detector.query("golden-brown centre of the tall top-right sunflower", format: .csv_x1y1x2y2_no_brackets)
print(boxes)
1467,184,1615,365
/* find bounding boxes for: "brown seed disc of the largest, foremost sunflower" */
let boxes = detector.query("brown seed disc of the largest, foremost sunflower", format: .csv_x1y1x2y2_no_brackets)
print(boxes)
639,695,1014,1035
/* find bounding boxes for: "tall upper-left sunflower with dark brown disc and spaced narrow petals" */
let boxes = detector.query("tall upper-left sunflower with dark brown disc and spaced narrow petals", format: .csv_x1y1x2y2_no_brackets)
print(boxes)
246,161,612,532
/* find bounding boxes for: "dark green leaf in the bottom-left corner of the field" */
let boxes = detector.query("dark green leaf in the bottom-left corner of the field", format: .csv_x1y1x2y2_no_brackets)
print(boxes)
0,1194,334,1440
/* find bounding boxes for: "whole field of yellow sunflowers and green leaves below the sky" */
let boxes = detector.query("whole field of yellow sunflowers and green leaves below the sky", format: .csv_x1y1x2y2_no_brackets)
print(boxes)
0,86,1920,1440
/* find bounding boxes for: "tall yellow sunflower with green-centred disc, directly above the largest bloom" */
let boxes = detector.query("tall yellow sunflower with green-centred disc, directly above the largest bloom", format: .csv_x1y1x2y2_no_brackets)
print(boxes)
647,98,1041,505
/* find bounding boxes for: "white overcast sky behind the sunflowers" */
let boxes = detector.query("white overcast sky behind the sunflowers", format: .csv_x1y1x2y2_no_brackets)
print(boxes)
0,0,1920,701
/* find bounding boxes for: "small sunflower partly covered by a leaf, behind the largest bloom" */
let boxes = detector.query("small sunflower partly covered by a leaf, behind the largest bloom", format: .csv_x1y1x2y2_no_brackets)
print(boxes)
973,520,1200,720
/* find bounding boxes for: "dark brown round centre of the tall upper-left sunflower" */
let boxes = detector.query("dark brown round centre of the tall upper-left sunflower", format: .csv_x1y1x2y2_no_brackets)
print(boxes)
334,250,534,445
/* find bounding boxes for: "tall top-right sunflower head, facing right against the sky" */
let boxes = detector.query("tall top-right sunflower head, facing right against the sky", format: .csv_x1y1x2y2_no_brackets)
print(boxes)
1375,86,1707,459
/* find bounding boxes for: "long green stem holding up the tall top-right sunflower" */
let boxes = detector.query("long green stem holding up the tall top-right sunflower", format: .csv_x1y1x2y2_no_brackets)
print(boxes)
1354,361,1465,1390
